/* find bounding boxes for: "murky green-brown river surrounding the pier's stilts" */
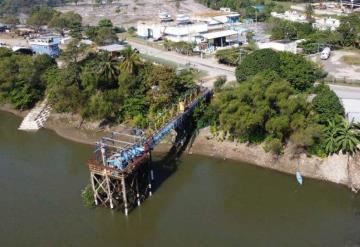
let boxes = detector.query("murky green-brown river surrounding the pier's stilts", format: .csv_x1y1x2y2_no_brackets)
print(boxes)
0,112,360,247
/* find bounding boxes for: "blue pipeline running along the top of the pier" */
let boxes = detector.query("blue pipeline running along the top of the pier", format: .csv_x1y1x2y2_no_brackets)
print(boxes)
101,91,210,170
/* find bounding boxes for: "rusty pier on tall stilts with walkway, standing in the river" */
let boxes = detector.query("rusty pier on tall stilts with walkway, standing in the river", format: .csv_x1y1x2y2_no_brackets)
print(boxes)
88,87,211,215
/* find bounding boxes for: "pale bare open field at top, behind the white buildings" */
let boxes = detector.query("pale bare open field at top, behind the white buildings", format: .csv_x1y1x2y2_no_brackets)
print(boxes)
56,0,209,27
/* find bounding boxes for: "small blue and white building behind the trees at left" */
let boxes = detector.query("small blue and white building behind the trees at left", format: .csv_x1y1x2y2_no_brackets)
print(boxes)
29,37,60,57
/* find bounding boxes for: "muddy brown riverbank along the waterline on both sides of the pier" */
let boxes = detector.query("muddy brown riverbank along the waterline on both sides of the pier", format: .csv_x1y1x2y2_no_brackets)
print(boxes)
0,106,360,192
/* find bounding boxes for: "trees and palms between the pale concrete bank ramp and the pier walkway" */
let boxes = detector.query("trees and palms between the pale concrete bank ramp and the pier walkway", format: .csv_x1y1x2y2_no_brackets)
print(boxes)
46,44,194,127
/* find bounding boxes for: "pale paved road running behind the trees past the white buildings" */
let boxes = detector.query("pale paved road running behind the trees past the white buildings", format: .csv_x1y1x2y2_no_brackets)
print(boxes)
128,40,360,100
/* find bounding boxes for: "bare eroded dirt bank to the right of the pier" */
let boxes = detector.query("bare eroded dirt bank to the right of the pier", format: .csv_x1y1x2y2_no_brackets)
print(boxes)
189,129,360,191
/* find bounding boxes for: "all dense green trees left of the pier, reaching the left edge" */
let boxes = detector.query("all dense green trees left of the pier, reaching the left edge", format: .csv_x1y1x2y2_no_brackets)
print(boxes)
0,43,194,127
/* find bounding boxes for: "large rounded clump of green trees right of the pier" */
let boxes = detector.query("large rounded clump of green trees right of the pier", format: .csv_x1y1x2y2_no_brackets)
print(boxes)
202,49,350,155
